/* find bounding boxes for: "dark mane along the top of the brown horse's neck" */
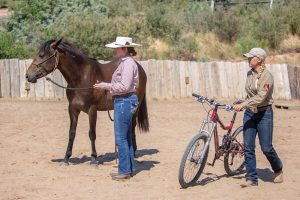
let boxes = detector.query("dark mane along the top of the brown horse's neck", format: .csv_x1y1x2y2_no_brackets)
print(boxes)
41,39,97,60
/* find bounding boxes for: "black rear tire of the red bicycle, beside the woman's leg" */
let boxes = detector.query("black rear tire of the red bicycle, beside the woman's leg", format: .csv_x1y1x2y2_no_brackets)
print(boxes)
224,126,245,176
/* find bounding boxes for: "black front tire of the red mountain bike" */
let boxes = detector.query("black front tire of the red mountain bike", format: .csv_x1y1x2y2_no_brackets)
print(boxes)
178,132,209,188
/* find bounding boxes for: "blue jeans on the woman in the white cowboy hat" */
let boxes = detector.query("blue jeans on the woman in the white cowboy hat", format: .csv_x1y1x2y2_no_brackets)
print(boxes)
114,95,138,174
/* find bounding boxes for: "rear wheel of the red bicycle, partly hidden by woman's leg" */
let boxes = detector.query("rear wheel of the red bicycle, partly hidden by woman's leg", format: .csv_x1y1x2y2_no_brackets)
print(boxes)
224,126,245,176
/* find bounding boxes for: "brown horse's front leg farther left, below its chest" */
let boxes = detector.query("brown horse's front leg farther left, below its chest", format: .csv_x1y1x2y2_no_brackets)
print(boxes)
61,104,80,165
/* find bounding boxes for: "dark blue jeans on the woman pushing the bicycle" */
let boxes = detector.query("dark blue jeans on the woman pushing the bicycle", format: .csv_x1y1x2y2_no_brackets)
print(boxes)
244,107,282,183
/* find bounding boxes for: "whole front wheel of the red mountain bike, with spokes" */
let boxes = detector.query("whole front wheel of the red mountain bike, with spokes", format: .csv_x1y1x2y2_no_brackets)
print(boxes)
178,132,209,188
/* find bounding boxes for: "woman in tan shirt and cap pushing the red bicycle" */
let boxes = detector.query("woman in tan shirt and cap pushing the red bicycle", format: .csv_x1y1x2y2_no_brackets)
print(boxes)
234,48,283,187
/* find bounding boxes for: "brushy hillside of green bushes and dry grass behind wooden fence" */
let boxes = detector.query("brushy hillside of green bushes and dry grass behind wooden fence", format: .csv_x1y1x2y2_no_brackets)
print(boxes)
0,0,300,63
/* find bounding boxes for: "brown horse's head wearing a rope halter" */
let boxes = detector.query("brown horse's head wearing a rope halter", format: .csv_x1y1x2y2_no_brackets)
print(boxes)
26,39,61,83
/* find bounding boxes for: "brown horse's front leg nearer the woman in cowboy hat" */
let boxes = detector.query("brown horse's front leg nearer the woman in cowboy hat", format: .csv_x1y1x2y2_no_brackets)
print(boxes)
88,105,97,166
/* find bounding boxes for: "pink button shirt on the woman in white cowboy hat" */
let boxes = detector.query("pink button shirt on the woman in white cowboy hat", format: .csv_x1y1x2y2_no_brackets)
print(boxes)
100,56,139,96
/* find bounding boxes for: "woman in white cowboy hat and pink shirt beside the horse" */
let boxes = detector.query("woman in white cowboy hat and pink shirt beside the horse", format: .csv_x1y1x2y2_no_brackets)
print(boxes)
94,37,140,180
